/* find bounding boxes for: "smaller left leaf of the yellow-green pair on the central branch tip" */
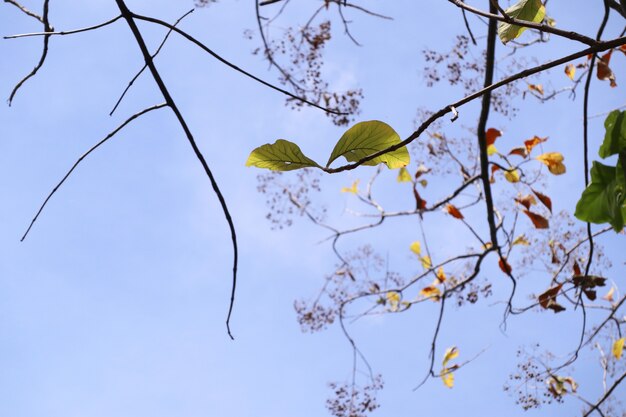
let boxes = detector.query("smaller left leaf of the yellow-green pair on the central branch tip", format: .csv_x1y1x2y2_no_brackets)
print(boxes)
246,139,319,171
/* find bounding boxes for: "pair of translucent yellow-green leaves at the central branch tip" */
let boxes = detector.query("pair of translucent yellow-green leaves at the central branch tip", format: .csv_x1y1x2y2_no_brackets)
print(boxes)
246,120,410,171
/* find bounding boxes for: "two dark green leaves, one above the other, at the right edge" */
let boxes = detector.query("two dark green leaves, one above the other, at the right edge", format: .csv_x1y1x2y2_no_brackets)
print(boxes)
574,110,626,232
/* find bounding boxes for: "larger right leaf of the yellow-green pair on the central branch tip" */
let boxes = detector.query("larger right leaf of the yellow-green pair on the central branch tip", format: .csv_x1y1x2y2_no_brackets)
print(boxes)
326,120,410,169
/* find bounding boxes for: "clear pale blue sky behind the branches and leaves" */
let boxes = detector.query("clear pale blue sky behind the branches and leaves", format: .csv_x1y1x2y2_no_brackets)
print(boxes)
0,0,626,417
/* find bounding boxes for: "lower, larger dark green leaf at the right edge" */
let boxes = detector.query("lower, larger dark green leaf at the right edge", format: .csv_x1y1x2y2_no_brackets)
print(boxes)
574,161,626,232
